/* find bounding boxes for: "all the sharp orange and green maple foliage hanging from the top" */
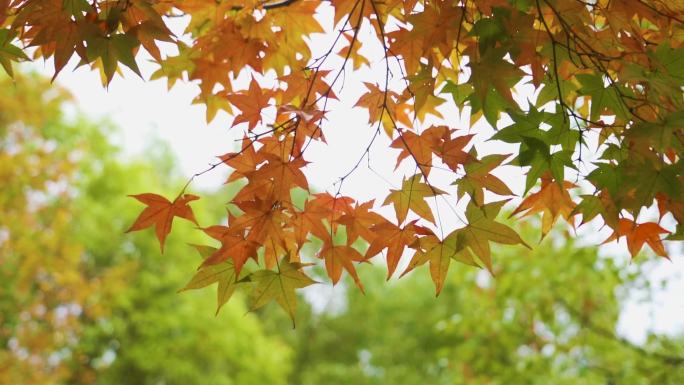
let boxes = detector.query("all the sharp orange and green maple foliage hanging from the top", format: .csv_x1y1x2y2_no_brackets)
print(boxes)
0,0,684,315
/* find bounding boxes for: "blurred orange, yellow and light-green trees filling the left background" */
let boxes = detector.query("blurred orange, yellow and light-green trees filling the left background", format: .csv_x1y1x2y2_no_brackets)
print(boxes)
0,76,291,385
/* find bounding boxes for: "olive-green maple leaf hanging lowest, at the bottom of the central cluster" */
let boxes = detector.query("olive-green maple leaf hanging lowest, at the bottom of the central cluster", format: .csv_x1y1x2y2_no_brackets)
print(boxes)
242,258,317,327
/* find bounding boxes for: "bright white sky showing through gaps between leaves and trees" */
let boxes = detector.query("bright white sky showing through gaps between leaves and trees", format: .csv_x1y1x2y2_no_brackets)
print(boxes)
22,9,684,342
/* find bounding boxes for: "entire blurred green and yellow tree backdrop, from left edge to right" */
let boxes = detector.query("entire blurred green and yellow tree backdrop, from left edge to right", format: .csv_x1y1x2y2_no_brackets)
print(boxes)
0,75,684,385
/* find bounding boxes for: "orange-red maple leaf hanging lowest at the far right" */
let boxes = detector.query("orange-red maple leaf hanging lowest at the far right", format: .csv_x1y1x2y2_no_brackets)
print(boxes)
603,218,670,259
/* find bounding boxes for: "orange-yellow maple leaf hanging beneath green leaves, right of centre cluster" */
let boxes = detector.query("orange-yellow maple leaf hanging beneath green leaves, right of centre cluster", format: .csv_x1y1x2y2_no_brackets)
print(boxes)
509,174,586,239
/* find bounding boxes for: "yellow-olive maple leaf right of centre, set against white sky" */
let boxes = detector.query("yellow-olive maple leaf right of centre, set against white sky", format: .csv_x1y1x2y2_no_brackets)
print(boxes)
383,174,446,223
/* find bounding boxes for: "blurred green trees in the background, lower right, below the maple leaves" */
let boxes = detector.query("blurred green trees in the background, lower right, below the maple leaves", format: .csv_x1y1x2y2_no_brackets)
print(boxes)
266,237,684,385
